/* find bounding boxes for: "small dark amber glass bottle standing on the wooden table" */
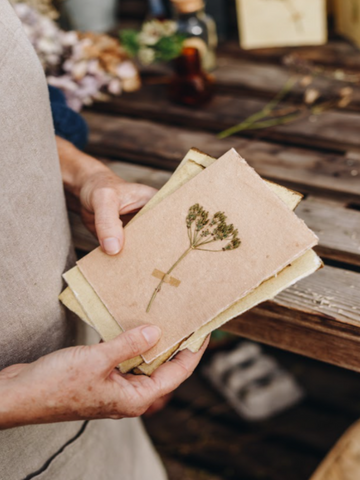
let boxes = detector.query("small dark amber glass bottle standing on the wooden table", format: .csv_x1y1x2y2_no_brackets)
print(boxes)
169,47,214,107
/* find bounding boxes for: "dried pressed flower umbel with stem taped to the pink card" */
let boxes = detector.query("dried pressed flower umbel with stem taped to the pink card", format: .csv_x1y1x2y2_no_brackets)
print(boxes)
146,203,241,312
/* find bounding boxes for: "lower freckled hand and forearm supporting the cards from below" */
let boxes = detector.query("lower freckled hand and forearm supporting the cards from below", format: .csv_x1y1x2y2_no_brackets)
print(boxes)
0,325,207,428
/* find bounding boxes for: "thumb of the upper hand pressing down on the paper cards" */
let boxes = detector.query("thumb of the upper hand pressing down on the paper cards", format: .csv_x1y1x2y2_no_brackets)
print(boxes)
94,195,124,255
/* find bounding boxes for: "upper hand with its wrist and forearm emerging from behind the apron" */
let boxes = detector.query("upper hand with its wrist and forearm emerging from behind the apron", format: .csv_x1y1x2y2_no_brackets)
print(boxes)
56,137,156,255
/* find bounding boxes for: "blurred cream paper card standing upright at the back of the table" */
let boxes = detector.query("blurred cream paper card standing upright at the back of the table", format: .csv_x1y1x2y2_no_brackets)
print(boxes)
237,0,327,49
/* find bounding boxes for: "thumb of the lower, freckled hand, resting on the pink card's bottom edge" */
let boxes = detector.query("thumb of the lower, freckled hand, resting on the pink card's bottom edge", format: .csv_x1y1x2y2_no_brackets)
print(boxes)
97,325,161,372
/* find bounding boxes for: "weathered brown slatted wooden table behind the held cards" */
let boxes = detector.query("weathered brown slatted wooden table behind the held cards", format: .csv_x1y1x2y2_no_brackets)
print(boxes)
72,41,360,371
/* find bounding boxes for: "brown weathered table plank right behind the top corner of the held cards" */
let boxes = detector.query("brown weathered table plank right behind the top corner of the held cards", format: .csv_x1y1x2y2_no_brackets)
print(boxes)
84,112,360,203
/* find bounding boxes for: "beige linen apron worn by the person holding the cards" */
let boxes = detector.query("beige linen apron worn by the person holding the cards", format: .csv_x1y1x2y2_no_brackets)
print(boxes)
0,0,165,480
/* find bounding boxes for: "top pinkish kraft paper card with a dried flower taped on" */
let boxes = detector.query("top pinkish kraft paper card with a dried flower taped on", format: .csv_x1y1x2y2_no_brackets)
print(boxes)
78,150,317,363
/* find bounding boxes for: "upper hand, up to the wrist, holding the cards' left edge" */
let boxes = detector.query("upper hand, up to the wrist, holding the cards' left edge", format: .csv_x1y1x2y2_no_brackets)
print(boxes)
79,169,156,255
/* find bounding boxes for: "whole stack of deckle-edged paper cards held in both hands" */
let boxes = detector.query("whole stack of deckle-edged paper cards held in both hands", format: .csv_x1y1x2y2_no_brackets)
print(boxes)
60,149,321,374
